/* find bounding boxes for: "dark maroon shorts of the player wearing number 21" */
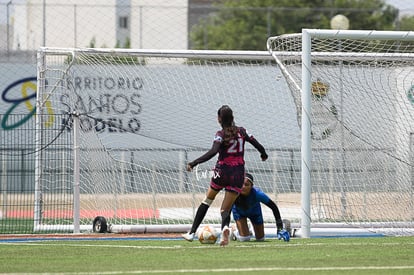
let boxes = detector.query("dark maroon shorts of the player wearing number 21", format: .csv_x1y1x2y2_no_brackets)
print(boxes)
210,165,244,194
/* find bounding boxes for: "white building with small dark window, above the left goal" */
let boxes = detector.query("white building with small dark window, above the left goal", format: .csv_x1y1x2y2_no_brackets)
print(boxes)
9,0,188,50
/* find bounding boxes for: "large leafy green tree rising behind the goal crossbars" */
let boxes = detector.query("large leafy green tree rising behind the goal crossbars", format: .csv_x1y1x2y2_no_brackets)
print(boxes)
190,0,398,50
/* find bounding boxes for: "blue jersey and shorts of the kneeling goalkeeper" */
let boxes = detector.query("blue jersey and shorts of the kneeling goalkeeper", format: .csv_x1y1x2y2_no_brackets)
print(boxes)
232,186,270,221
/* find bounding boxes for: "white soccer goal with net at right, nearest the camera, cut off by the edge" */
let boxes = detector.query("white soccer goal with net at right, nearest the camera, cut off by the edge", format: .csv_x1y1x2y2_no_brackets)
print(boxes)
267,29,414,237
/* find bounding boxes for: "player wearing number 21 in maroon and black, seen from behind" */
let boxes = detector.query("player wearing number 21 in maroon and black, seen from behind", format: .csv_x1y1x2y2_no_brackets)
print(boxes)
182,105,268,246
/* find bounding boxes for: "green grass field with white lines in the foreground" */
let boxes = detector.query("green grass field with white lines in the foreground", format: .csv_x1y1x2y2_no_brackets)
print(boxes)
0,237,414,274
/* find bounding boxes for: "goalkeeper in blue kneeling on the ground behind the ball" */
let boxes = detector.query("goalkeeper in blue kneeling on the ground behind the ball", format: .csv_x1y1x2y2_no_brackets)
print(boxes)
231,173,290,242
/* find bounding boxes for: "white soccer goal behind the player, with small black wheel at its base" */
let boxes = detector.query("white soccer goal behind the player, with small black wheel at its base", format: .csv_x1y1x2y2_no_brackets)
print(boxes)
33,48,300,233
